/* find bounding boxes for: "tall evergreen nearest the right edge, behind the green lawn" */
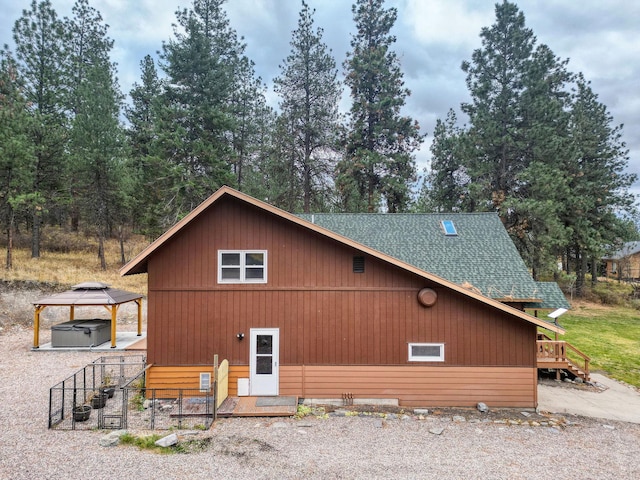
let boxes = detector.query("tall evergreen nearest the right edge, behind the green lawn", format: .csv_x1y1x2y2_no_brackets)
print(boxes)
562,75,637,293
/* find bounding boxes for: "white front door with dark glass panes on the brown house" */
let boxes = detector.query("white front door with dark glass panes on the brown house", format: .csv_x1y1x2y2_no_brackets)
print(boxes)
249,328,280,396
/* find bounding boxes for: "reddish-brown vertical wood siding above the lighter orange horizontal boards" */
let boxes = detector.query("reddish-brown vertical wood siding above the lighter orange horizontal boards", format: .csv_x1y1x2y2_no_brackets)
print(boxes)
147,198,536,367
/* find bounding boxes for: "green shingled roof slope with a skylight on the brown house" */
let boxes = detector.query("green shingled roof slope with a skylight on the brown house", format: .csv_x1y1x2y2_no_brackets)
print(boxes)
300,213,566,308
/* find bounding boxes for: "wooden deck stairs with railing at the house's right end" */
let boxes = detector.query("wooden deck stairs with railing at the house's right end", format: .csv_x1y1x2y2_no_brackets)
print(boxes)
536,333,591,382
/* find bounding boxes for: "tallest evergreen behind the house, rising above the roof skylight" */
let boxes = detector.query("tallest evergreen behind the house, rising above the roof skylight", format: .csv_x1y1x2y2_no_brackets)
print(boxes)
462,1,535,214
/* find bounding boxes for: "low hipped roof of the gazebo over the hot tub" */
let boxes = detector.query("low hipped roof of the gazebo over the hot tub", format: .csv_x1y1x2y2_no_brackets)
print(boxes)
33,282,142,306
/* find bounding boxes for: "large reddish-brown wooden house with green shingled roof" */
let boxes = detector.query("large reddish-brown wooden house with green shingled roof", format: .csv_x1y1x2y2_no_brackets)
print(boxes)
121,187,566,407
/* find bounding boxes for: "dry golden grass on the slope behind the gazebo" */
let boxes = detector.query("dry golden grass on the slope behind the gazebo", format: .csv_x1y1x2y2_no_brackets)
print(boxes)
1,237,147,295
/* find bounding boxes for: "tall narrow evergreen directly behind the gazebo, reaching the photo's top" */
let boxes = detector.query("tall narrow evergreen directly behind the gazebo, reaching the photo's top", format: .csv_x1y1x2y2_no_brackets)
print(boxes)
67,0,128,270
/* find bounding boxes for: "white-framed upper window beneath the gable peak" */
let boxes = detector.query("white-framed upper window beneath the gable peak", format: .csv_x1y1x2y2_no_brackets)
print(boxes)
218,250,267,283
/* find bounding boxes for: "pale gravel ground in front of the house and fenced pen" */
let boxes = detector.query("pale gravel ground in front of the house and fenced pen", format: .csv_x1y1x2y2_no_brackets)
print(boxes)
0,327,640,480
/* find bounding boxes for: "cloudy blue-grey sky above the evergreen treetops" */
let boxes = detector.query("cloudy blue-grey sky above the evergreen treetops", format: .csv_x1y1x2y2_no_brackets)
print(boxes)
0,0,640,194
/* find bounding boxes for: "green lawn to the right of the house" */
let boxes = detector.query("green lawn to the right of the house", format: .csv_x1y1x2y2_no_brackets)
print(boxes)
558,305,640,387
